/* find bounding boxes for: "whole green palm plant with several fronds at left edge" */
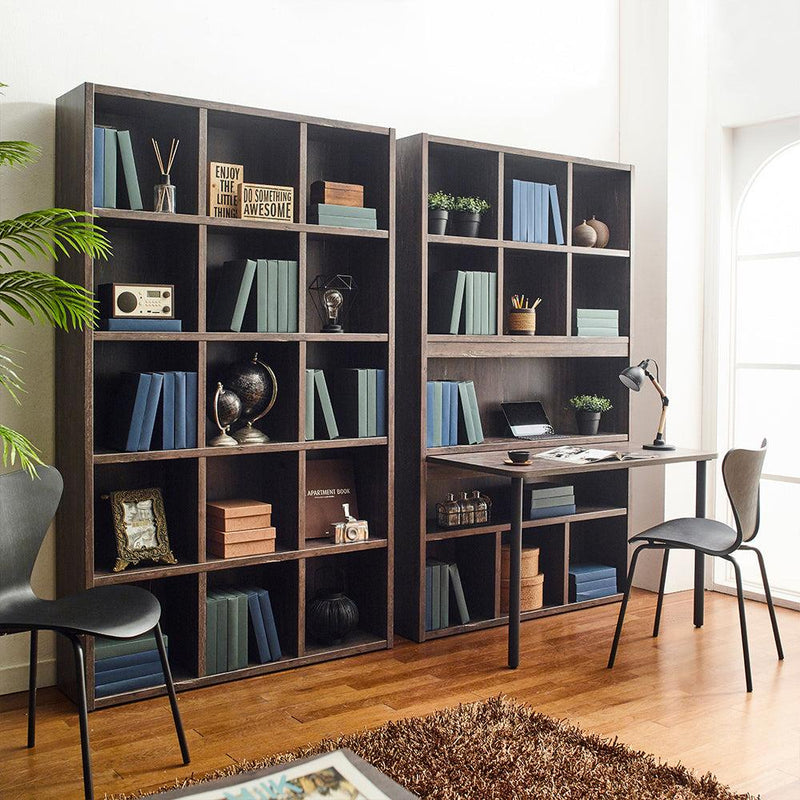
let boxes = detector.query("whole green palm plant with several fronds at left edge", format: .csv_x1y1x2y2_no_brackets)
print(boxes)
0,92,111,477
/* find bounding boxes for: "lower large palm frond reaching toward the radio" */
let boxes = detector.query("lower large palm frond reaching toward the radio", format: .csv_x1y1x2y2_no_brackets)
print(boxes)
0,270,97,330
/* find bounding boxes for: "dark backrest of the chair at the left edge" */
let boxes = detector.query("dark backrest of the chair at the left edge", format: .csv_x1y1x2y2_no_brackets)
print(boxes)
0,467,64,603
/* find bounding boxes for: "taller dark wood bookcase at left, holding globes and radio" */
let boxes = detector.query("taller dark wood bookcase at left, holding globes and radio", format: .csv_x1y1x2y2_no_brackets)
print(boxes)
56,83,395,708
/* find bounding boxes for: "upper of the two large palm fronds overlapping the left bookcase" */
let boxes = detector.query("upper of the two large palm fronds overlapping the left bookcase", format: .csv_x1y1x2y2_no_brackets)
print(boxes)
0,208,111,266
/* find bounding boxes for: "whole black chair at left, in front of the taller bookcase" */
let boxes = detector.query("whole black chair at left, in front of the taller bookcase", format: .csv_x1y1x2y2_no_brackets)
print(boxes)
0,467,189,800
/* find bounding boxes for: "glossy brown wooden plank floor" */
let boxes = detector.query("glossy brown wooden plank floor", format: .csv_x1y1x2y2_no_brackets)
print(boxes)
0,592,800,800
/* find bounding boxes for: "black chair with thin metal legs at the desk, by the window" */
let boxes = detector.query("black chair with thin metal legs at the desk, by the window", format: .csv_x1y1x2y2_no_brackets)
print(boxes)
608,439,783,692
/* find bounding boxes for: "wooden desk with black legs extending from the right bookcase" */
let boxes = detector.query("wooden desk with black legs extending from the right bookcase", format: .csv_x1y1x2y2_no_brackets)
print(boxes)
427,442,717,669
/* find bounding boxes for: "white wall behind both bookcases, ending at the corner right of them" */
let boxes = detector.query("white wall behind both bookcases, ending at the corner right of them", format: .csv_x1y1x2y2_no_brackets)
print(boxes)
0,0,619,693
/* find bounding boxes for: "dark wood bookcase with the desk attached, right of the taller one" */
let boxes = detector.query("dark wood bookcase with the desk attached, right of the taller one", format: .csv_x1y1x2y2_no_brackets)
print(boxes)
395,134,633,641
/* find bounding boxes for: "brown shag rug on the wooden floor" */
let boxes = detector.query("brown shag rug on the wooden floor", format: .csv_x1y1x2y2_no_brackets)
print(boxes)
108,697,754,800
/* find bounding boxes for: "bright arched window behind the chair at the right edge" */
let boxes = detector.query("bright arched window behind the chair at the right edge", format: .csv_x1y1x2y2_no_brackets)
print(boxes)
714,142,800,600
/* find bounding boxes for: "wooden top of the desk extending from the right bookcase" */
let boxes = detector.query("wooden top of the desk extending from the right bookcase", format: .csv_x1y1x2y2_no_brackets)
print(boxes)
427,445,717,481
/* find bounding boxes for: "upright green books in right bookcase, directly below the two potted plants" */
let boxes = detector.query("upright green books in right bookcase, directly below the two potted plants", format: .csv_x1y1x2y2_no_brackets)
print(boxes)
428,270,497,336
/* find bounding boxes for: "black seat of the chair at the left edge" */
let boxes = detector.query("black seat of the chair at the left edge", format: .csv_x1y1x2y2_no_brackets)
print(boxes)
0,586,161,639
